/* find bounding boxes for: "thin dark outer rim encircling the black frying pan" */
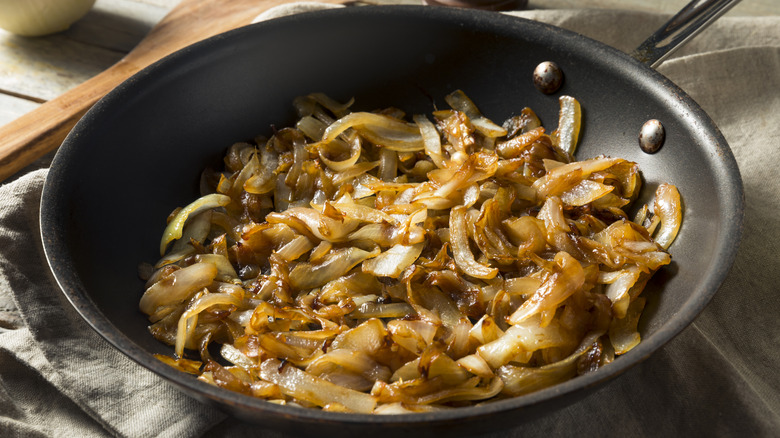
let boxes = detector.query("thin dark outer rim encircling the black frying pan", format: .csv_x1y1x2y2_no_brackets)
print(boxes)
40,2,744,425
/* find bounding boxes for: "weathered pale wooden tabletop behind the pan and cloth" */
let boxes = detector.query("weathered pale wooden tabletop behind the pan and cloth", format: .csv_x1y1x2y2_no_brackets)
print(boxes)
0,0,780,181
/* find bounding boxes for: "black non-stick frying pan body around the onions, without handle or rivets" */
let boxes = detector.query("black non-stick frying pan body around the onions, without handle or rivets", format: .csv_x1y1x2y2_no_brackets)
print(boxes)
41,6,743,436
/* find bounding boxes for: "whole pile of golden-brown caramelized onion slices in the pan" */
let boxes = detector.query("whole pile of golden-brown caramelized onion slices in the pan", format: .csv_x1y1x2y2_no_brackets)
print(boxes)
140,91,682,414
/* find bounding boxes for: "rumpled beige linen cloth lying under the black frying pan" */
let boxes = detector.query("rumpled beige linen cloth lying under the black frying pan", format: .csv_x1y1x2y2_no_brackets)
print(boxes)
0,3,780,437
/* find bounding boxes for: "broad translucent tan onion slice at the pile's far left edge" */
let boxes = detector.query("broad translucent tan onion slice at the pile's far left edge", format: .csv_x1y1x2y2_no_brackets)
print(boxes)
138,263,218,315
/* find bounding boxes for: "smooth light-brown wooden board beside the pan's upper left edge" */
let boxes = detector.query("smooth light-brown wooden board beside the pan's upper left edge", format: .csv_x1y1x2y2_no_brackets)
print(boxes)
0,0,339,181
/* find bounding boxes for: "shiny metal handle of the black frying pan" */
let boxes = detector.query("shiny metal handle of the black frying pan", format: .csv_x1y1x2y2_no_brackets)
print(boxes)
631,0,740,68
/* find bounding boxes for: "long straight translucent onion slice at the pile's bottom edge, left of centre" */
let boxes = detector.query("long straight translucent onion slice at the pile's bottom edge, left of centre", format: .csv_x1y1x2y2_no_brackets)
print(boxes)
260,359,376,414
